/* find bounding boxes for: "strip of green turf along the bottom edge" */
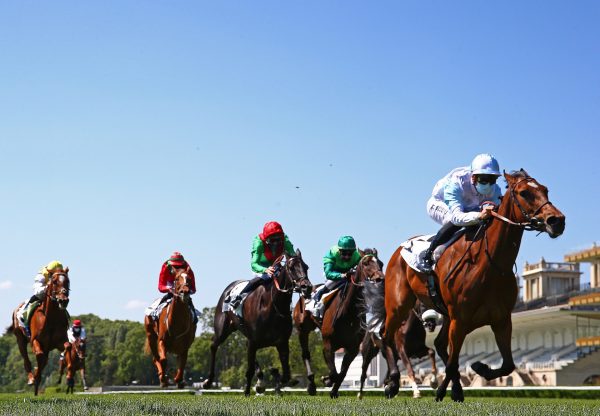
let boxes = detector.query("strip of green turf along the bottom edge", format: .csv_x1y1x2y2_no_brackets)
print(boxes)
0,394,600,416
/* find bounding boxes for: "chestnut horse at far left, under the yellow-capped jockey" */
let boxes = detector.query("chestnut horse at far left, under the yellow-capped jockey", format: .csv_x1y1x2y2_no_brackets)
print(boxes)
7,267,70,396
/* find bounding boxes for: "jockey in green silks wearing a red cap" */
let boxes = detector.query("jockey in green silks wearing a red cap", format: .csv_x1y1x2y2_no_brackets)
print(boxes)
229,221,294,308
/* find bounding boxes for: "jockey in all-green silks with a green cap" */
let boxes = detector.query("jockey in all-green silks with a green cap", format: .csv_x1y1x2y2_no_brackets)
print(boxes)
313,235,361,319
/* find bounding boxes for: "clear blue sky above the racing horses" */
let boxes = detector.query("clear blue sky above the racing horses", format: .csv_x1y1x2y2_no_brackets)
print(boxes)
0,1,600,325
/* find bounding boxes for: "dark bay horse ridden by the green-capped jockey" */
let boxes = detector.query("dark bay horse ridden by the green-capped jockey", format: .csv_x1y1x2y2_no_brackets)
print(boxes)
294,254,383,398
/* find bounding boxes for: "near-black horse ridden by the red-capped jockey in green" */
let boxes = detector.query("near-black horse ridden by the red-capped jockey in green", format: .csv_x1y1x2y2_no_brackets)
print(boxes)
202,250,312,396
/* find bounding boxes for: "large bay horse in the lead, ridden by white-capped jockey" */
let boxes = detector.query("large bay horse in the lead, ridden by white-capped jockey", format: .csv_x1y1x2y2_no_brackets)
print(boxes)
380,169,565,402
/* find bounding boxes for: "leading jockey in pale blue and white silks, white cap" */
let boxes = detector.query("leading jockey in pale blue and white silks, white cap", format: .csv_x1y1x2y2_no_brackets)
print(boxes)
420,153,502,273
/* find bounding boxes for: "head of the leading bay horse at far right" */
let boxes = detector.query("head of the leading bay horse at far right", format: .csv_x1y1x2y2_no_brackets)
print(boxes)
504,169,565,238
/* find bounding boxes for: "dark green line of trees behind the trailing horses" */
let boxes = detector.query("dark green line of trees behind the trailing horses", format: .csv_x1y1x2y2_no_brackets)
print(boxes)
0,308,327,392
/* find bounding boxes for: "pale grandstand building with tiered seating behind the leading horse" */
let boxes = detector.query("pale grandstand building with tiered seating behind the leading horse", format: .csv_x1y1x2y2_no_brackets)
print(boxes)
336,244,600,387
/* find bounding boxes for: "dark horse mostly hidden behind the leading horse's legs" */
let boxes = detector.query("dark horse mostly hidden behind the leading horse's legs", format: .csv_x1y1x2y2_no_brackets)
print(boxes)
358,300,438,399
